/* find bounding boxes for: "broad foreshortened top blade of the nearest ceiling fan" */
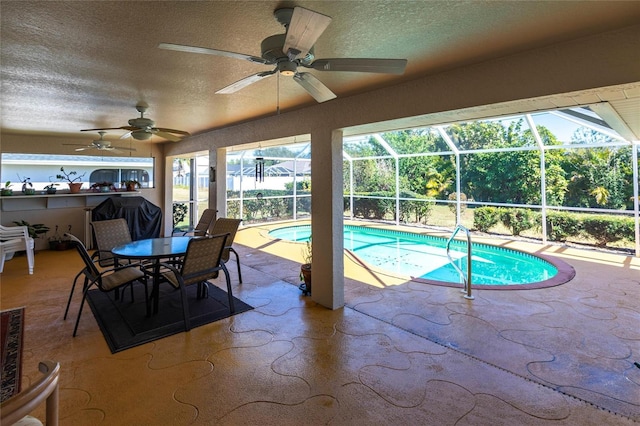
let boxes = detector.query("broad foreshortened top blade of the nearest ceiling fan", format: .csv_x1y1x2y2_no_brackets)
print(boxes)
282,7,331,61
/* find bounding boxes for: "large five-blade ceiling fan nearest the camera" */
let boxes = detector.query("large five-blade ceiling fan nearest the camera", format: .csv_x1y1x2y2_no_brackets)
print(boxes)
158,7,407,102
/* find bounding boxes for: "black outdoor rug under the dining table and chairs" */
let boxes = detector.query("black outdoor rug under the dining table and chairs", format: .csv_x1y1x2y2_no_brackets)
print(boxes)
87,283,253,353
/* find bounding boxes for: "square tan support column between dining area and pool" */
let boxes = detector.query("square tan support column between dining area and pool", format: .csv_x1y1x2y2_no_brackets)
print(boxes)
311,130,344,309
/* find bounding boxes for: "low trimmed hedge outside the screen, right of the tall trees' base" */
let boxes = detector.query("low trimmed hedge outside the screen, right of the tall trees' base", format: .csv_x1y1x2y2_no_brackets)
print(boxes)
473,207,635,247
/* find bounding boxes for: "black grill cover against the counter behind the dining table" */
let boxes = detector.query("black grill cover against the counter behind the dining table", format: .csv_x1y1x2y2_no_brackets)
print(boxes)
91,197,162,241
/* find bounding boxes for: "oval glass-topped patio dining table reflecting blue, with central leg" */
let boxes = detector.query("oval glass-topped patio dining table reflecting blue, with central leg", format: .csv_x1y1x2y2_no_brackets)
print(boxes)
111,237,193,314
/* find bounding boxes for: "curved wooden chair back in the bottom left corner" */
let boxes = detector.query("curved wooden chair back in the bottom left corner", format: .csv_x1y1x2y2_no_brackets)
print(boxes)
0,361,60,426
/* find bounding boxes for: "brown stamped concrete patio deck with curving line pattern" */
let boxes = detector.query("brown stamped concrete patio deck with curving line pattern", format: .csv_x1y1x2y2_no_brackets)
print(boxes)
0,227,640,425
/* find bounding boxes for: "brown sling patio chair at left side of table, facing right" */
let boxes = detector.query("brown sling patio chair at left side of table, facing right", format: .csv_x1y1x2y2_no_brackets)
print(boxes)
64,234,149,337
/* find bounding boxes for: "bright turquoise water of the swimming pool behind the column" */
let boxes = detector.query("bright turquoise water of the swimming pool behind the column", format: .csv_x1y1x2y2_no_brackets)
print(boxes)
269,225,558,286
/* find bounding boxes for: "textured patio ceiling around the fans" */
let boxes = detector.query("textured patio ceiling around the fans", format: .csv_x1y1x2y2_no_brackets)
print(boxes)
0,0,640,142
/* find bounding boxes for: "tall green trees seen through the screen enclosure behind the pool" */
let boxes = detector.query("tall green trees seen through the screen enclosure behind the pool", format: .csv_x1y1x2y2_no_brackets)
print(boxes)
344,120,633,209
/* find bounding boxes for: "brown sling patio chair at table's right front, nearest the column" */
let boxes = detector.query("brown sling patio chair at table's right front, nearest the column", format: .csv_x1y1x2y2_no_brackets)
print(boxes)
160,234,235,331
